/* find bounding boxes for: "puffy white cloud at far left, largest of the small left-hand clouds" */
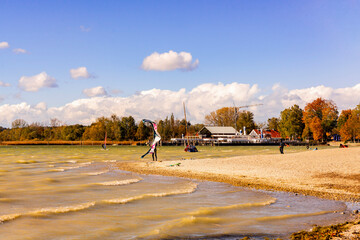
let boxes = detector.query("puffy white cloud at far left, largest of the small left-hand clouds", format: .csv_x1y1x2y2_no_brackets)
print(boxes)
19,72,58,92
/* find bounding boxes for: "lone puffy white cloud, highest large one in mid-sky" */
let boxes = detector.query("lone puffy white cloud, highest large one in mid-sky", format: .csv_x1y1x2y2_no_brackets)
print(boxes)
141,50,199,71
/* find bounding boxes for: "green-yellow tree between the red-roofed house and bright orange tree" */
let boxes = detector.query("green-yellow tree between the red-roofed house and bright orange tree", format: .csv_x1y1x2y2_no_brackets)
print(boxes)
279,104,304,139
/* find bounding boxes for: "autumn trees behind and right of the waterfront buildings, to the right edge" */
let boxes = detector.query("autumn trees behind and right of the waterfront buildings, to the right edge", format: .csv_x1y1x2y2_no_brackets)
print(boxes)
205,98,360,142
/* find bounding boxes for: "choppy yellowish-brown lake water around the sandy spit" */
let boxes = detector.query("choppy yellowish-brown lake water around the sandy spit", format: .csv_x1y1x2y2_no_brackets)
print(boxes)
0,146,354,239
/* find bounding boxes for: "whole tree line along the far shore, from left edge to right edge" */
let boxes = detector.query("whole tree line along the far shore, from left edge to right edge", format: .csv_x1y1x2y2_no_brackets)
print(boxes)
0,98,360,141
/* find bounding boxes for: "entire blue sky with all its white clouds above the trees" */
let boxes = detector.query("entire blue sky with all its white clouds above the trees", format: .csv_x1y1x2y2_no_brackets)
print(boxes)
0,0,360,127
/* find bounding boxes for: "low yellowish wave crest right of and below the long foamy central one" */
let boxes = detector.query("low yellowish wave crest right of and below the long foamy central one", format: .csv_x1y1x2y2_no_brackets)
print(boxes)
187,198,276,216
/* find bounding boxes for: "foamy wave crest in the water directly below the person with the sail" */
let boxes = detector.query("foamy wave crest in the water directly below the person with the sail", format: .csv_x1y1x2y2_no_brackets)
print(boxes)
103,183,197,204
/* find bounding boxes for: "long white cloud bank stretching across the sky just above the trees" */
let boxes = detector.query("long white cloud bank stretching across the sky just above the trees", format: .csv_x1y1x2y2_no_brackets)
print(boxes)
0,82,360,127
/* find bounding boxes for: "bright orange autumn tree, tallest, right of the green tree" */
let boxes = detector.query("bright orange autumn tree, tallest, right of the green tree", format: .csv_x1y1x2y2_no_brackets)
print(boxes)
303,98,338,141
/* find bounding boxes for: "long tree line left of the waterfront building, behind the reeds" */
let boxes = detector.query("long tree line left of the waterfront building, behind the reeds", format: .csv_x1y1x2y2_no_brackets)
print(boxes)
0,114,204,141
